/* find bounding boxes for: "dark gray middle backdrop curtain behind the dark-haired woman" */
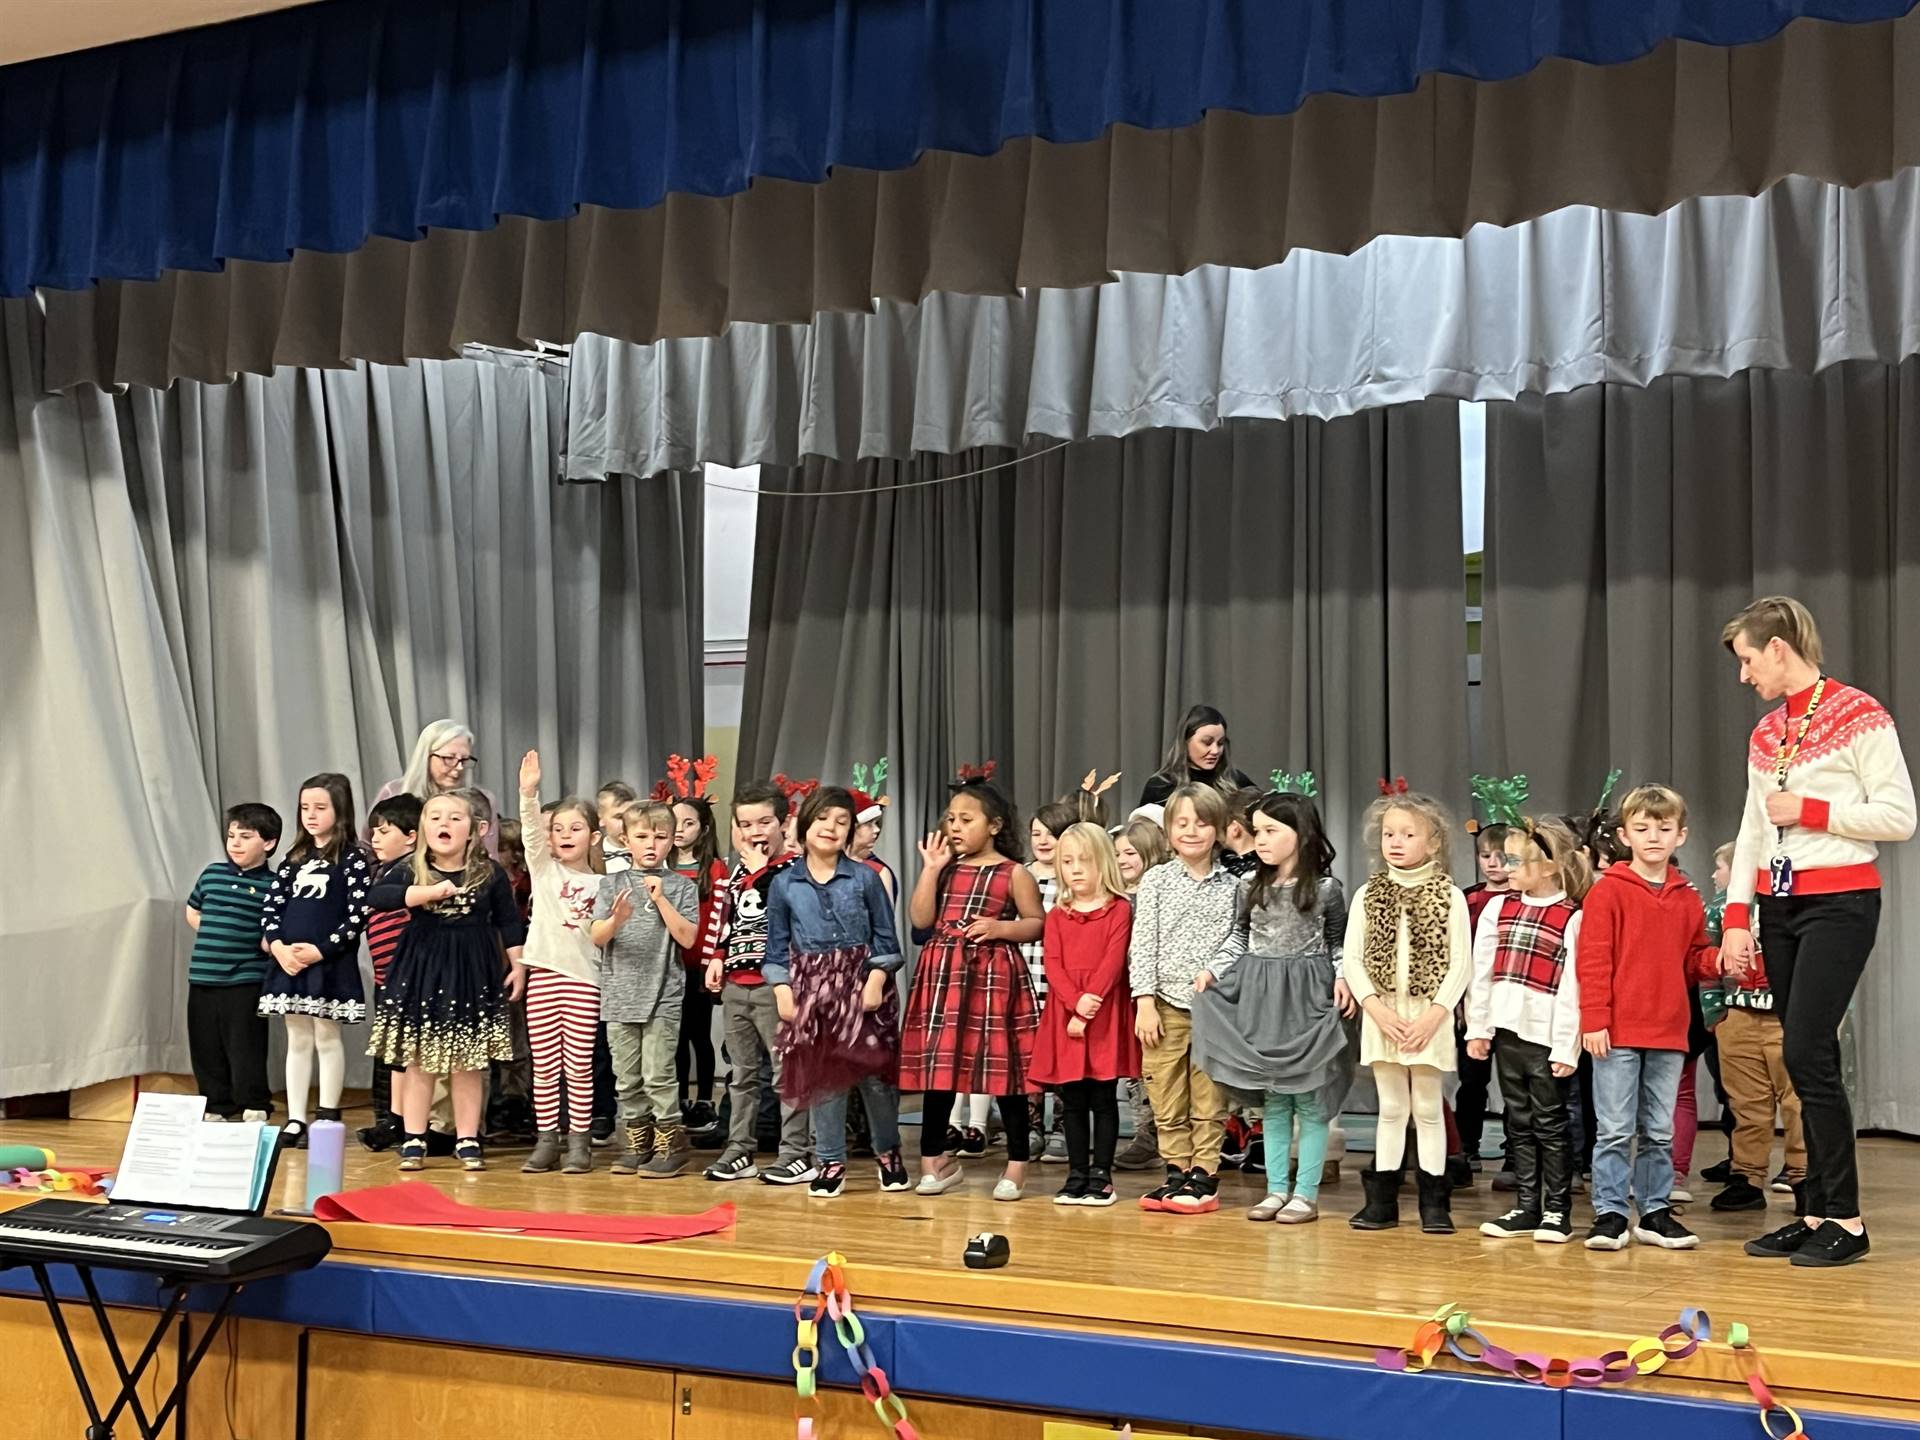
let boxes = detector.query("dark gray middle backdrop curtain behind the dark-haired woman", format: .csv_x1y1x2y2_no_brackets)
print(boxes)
739,401,1467,898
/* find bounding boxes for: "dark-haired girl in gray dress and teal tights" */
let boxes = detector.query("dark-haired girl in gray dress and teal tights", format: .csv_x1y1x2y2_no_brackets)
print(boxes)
1192,793,1356,1225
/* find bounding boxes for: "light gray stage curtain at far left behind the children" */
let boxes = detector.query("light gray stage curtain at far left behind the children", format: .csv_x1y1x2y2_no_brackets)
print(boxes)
0,303,701,1094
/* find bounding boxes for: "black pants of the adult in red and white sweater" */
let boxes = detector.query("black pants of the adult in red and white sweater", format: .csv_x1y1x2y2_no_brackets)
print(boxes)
1759,891,1880,1219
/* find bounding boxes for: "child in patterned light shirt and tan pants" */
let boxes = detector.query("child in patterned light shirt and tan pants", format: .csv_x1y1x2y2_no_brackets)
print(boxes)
1127,785,1238,1215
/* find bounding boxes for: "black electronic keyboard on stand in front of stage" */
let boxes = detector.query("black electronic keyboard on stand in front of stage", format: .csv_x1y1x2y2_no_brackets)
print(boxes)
0,1200,332,1284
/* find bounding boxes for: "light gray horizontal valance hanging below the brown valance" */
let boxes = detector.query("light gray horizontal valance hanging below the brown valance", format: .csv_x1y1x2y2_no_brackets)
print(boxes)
568,169,1920,478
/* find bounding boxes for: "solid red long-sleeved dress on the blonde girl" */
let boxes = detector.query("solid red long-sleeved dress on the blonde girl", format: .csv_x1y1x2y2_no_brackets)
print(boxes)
1027,897,1140,1085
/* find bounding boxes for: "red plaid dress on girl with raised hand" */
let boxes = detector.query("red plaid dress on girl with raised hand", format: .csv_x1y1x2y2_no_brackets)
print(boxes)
900,860,1041,1094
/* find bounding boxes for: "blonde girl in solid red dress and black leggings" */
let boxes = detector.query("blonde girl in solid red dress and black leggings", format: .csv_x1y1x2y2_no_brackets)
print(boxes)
1027,824,1140,1206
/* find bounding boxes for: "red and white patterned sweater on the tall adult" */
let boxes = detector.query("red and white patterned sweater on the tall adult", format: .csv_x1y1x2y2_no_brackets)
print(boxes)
1724,680,1914,929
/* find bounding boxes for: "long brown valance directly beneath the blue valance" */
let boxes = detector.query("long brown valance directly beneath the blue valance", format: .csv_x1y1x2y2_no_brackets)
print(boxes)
46,15,1920,390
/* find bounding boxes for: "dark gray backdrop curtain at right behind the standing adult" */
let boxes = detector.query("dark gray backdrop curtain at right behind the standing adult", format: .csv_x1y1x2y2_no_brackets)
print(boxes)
1482,361,1920,1133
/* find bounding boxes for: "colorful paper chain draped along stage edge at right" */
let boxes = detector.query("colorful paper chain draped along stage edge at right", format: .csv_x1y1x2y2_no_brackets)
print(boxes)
1373,1304,1807,1440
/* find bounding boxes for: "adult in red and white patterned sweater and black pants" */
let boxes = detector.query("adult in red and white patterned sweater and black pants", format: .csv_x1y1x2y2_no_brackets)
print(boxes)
1720,595,1914,1265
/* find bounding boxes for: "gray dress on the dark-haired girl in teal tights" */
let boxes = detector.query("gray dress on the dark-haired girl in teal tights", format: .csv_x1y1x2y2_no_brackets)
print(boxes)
1192,877,1359,1117
